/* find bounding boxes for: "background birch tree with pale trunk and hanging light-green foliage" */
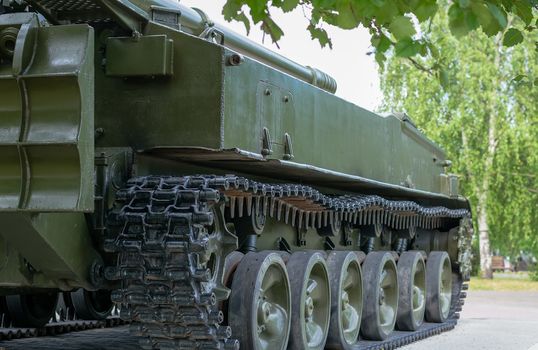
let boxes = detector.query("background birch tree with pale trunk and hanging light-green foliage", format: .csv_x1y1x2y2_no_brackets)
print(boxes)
381,11,538,277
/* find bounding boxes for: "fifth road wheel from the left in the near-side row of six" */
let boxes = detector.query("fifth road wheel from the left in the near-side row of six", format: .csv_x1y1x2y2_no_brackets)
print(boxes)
396,251,426,331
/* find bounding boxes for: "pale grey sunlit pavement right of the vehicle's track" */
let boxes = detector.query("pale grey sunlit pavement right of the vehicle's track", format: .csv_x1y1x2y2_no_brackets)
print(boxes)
402,291,538,350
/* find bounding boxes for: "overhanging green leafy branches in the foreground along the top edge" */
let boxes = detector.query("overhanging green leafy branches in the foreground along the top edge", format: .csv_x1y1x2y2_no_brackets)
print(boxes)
223,0,538,86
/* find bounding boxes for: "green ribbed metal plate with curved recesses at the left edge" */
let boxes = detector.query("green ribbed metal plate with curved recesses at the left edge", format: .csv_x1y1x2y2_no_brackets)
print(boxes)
0,13,94,212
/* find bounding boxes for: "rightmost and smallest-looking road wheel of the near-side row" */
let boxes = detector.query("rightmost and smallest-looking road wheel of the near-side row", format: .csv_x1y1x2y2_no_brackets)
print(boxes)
426,252,452,323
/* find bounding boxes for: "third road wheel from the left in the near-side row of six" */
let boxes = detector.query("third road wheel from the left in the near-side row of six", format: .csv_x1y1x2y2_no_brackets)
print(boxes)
325,251,362,350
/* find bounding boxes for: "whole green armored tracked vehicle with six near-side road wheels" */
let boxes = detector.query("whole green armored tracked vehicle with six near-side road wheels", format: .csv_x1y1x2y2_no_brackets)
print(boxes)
0,0,472,350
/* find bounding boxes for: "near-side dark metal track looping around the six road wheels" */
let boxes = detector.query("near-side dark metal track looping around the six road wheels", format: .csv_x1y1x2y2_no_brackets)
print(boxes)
105,176,470,350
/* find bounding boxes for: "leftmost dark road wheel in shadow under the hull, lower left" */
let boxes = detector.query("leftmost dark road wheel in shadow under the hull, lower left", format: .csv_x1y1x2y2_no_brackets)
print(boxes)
6,292,58,328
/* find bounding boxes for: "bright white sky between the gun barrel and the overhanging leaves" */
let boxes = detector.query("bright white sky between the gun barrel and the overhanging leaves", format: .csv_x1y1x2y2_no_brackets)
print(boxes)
181,0,382,110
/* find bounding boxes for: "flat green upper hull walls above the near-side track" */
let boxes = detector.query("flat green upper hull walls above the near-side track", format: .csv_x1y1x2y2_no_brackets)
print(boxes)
95,22,457,195
